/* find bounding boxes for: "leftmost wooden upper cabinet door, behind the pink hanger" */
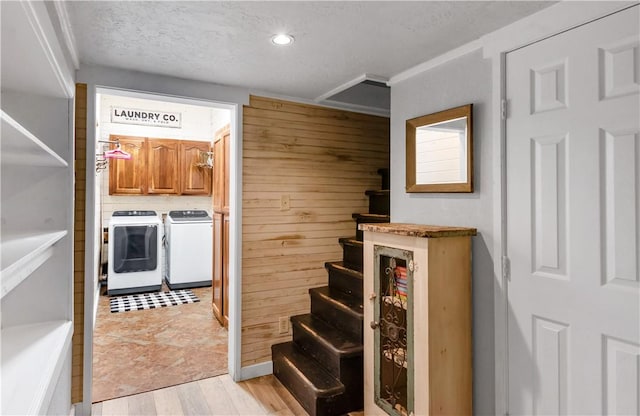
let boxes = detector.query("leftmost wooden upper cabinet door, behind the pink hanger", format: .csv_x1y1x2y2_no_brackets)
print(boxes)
109,136,147,195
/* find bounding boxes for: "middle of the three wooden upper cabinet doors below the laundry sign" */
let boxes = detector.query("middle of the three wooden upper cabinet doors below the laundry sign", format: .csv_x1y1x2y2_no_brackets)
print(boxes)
147,139,180,194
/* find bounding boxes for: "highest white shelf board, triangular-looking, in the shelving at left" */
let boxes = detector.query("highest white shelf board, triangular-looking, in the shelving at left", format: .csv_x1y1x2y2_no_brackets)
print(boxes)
0,110,69,167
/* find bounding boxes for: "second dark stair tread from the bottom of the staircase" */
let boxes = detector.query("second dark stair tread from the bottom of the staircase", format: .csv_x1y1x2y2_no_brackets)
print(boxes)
291,314,363,357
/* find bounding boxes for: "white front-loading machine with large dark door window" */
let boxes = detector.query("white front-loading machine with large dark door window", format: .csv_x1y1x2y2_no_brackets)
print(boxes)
107,211,162,296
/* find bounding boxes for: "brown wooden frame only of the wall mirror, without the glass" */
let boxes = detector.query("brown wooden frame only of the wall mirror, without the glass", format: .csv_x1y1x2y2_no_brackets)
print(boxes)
405,104,473,192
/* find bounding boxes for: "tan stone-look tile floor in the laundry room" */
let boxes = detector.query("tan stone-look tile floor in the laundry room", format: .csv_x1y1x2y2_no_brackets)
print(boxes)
92,287,228,403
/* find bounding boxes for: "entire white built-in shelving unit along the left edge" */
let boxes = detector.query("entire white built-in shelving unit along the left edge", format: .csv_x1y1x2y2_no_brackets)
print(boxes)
0,1,74,415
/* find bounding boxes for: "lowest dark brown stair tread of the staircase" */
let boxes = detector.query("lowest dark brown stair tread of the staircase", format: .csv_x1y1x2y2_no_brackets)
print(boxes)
272,342,345,397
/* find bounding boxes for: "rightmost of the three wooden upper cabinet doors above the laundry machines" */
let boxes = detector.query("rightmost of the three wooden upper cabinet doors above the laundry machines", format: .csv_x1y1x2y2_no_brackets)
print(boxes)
179,141,211,195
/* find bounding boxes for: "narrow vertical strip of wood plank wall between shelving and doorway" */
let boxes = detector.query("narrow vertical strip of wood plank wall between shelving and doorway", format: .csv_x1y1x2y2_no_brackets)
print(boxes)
71,84,87,403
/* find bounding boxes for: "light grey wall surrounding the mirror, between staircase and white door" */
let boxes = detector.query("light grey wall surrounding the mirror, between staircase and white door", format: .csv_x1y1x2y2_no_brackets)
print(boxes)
391,50,500,415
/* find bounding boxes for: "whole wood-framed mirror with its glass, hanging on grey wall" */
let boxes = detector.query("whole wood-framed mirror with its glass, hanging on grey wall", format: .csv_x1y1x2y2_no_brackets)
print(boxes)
406,104,473,192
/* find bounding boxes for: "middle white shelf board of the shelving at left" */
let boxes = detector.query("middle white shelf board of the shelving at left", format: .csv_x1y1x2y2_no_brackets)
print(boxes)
0,230,67,298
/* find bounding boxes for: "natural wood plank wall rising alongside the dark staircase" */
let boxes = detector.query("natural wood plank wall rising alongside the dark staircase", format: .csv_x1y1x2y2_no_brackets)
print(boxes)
242,96,389,366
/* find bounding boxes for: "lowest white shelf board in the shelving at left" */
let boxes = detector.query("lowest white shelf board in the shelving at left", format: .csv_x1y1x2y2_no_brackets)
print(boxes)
0,321,73,415
